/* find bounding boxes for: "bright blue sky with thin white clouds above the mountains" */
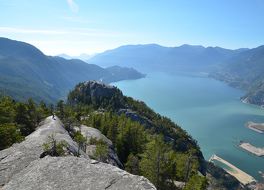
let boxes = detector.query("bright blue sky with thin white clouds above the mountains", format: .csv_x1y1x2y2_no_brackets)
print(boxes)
0,0,264,55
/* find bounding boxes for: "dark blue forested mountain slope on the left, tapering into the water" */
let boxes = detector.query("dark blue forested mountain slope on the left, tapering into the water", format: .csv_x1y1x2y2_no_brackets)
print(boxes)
0,38,144,102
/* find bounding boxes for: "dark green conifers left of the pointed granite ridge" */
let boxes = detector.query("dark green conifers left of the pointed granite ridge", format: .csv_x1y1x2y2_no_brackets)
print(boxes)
0,96,51,150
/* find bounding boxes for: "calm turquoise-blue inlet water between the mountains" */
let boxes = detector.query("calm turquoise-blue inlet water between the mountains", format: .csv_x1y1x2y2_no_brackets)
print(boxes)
113,73,264,181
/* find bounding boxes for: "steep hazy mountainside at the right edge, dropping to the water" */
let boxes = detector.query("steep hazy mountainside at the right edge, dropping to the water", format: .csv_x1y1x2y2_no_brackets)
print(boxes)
211,46,264,105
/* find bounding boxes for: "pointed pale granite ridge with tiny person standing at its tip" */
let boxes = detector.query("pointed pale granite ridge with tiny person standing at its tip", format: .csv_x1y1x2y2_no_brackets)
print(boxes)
0,117,85,186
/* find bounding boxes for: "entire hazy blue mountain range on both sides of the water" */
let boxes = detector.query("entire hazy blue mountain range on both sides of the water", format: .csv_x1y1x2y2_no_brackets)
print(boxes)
0,38,264,105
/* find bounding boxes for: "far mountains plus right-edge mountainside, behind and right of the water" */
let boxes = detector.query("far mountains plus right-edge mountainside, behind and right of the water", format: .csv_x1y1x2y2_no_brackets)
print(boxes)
89,44,264,105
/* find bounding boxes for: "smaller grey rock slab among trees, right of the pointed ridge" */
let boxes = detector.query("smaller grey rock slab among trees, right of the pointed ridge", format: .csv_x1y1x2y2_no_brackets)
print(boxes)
77,125,124,169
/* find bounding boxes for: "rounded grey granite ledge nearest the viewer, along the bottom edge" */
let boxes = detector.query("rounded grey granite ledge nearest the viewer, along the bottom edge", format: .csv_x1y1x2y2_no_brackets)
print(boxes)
2,156,156,190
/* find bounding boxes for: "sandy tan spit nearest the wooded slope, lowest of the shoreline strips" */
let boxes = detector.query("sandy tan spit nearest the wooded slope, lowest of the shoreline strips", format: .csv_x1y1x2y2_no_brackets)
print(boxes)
209,154,256,185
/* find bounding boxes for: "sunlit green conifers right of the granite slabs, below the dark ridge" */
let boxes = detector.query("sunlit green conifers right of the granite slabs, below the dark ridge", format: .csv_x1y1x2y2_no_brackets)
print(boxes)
82,111,207,190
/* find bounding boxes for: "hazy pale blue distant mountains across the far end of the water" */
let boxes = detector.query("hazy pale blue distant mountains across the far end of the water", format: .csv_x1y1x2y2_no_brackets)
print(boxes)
89,44,247,72
